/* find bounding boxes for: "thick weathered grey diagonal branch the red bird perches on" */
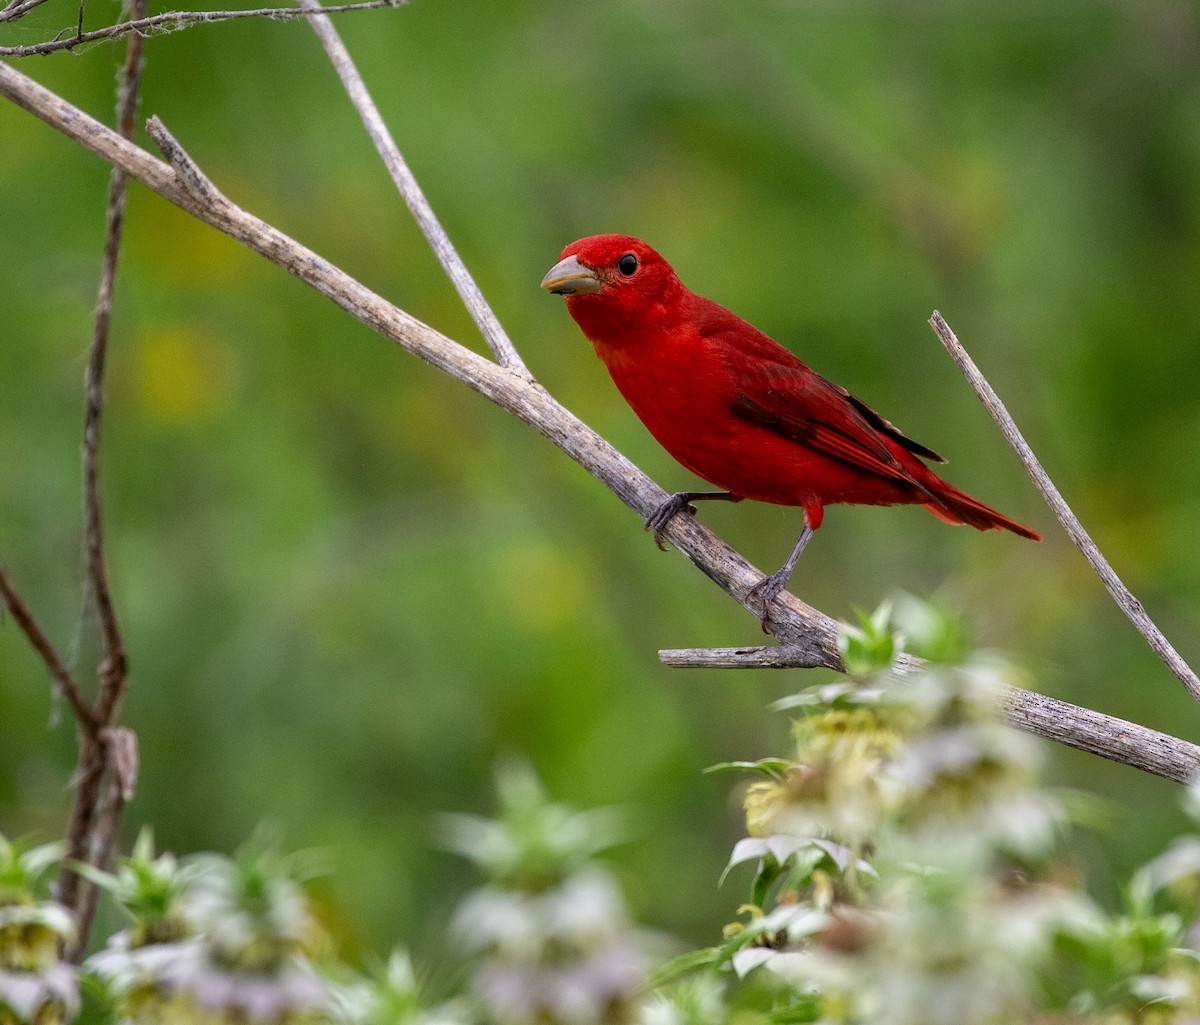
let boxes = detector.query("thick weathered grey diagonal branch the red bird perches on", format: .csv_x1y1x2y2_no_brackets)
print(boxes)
0,62,1200,779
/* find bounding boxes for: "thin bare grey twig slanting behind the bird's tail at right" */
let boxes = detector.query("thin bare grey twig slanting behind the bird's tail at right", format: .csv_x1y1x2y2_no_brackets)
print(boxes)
929,310,1200,701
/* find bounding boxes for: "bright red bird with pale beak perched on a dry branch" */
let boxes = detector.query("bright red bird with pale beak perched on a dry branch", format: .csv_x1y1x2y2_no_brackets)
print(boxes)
541,235,1042,617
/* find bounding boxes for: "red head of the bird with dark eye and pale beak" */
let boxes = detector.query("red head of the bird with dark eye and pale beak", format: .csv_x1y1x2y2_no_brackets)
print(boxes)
541,235,683,344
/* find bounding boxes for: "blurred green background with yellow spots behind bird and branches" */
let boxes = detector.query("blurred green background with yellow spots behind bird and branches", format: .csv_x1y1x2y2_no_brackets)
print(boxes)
0,0,1200,957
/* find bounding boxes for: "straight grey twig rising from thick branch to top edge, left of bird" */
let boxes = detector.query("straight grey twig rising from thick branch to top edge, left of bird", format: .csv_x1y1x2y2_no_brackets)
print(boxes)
298,0,530,377
